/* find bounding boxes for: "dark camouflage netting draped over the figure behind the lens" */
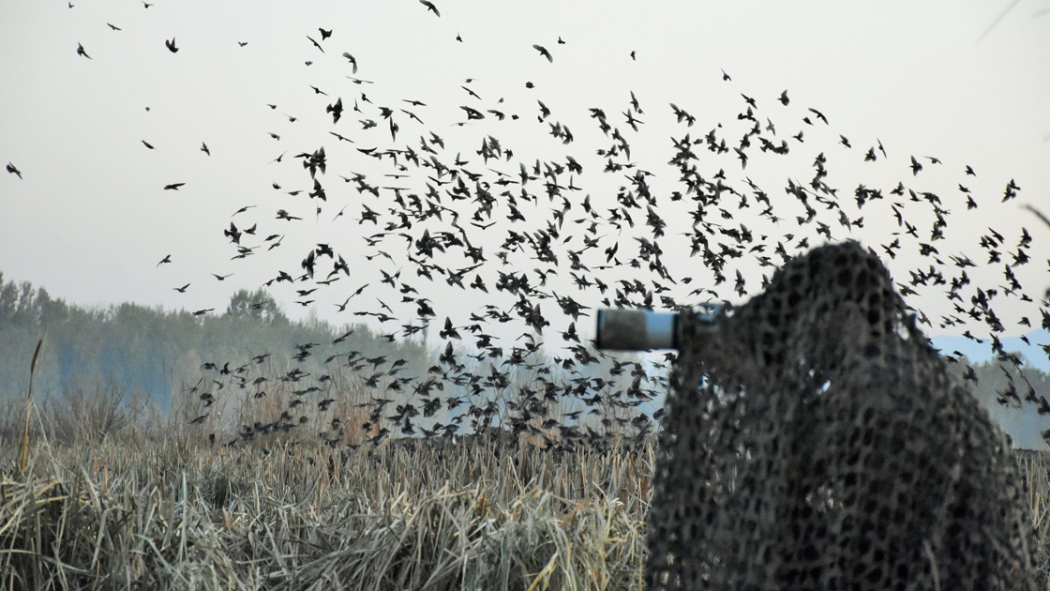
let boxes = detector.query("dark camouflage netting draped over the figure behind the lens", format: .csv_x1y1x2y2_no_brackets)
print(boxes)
646,242,1036,591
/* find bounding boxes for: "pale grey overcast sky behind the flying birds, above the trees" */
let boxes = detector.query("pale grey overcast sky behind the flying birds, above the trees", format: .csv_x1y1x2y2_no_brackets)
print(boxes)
0,0,1050,365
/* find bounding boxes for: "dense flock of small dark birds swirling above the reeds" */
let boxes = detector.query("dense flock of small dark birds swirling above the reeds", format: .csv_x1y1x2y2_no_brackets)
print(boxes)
7,0,1050,448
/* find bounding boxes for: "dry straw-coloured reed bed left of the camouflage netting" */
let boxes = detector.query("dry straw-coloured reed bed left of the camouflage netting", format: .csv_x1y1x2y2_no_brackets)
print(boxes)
0,439,652,590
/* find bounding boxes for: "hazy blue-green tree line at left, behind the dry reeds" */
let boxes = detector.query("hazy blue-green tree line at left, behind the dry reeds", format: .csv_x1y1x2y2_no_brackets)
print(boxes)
0,272,429,407
